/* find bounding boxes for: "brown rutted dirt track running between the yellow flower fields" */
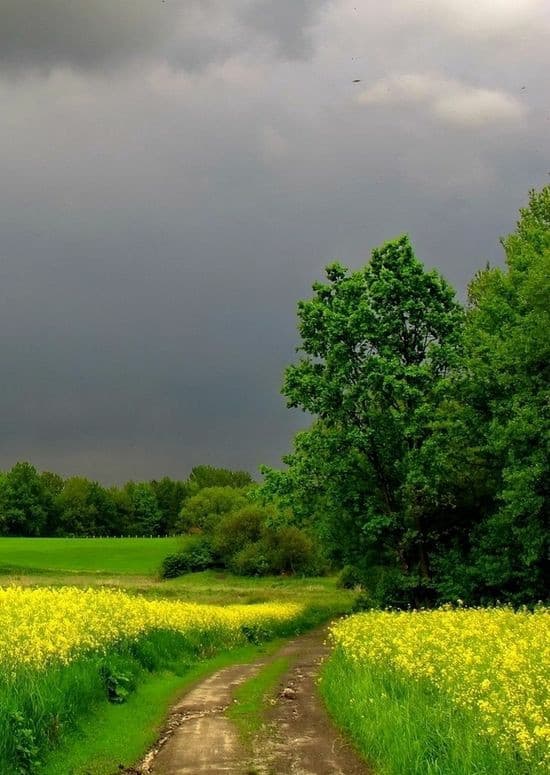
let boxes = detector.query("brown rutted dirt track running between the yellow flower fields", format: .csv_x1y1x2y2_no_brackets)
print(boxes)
134,630,369,775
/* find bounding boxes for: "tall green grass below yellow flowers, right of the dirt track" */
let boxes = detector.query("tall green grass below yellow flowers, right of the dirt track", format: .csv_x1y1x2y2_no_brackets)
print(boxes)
320,649,535,775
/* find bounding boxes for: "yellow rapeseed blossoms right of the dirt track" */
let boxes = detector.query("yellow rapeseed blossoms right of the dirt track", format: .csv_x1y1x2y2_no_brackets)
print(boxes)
331,606,550,767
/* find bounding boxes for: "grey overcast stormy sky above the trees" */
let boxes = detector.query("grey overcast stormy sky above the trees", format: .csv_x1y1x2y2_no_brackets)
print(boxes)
0,0,550,482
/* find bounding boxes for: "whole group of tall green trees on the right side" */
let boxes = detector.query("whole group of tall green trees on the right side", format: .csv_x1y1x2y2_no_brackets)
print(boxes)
262,186,550,606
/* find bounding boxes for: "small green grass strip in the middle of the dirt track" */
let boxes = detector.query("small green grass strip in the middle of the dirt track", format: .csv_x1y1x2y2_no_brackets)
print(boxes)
226,657,290,743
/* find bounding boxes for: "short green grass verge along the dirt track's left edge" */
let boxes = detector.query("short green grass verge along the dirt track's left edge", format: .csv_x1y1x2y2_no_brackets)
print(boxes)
40,639,282,775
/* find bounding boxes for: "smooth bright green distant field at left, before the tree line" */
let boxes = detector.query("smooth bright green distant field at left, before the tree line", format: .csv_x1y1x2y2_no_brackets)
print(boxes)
0,537,183,576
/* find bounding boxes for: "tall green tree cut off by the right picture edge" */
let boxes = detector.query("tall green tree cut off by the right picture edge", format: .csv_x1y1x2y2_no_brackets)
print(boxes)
463,186,550,602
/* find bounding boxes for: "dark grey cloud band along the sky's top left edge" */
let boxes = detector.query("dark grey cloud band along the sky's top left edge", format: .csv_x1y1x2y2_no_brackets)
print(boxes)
0,0,325,73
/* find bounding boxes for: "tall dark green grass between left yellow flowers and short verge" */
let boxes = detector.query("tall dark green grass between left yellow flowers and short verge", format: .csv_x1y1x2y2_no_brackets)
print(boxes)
0,596,327,775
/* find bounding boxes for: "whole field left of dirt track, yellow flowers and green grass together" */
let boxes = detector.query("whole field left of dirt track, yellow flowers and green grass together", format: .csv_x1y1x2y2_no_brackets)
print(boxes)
0,538,354,775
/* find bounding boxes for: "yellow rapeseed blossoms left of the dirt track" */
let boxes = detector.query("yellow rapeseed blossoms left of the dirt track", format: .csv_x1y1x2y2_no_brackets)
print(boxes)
0,587,302,673
